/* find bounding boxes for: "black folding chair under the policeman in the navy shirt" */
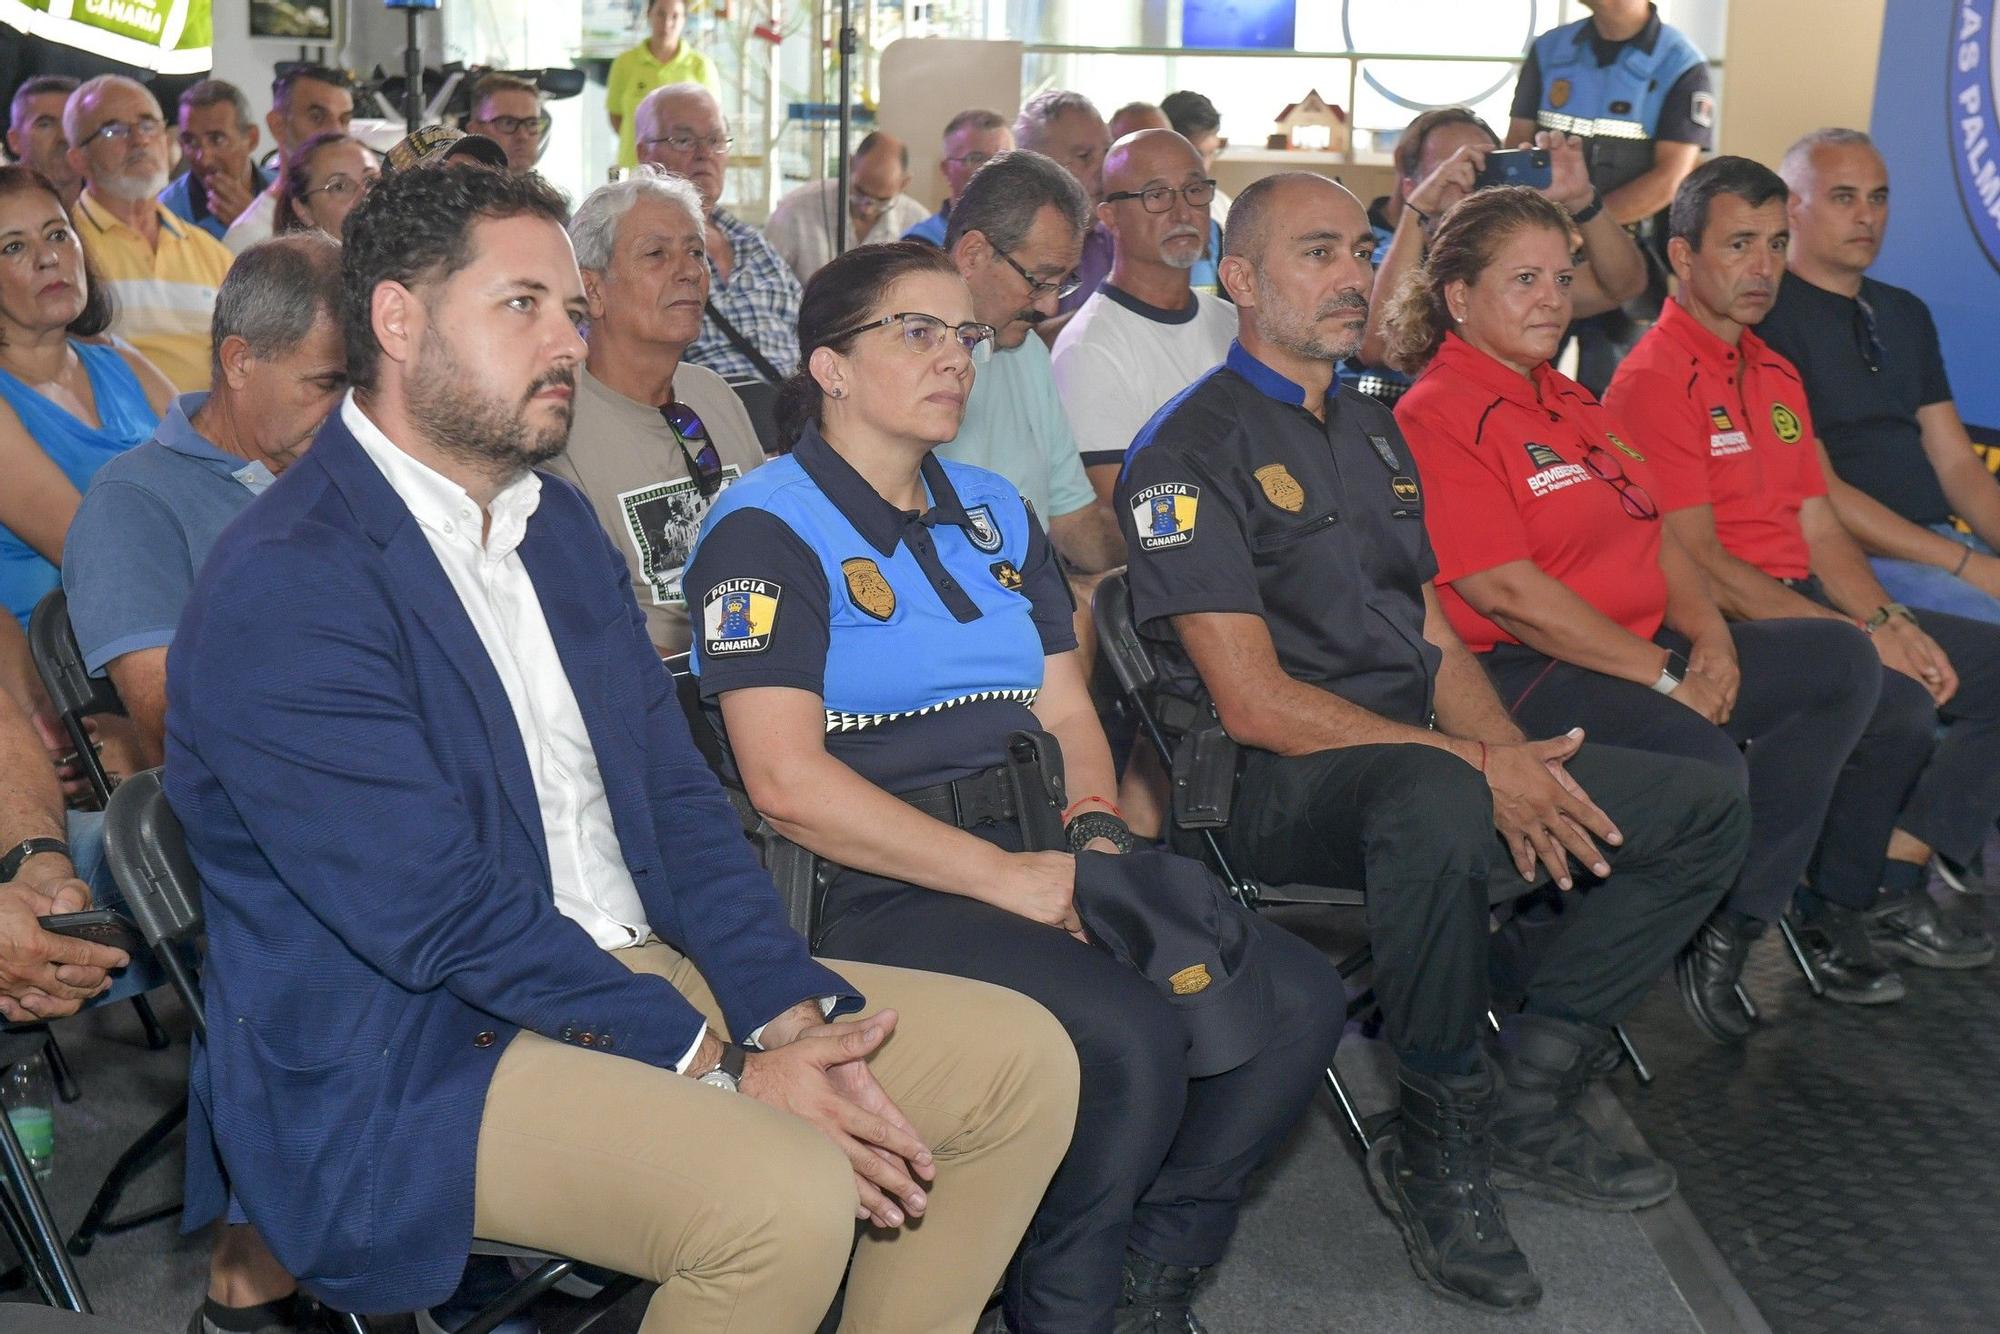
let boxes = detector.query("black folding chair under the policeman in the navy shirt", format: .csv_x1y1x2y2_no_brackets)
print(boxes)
1090,570,1652,1112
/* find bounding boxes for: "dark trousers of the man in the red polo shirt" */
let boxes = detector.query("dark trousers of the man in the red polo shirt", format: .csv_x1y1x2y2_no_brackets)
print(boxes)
1794,580,2000,888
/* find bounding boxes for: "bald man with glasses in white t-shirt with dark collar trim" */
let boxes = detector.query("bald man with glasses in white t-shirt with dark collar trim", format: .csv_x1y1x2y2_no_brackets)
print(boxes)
1052,130,1236,500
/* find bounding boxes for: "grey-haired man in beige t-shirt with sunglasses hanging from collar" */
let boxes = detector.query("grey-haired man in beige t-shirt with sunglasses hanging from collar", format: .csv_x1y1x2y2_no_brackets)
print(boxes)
544,168,764,656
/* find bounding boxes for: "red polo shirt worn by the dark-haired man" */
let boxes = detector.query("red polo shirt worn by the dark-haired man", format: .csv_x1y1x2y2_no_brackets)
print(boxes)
1604,298,1826,580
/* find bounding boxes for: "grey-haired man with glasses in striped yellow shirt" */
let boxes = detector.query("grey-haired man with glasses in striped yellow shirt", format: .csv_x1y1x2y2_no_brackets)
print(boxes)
62,74,234,394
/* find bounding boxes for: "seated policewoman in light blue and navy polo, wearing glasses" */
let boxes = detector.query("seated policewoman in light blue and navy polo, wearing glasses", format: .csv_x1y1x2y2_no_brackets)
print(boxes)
684,242,1344,1334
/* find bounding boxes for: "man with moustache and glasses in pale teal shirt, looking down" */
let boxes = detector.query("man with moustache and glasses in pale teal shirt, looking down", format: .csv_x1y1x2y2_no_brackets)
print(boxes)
938,150,1124,604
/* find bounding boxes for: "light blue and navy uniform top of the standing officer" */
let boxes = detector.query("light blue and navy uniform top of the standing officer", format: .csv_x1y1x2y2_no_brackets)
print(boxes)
1512,8,1716,194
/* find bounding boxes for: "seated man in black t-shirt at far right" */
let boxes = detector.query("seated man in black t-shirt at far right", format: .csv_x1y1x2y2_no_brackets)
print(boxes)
1758,130,2000,636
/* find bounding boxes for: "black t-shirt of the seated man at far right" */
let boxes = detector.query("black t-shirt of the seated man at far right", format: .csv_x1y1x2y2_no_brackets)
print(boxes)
1758,274,1952,528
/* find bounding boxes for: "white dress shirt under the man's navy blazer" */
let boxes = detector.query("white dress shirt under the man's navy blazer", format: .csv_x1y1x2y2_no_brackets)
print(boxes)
340,392,708,1070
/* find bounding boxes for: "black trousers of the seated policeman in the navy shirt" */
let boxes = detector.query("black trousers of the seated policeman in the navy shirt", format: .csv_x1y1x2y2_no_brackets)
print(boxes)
1226,746,1750,1072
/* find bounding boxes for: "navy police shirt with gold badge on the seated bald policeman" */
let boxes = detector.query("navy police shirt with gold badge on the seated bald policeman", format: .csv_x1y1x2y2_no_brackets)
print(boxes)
1116,344,1440,726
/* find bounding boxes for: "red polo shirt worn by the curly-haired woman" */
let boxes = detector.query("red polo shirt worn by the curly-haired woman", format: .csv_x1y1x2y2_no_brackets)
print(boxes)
1396,334,1666,654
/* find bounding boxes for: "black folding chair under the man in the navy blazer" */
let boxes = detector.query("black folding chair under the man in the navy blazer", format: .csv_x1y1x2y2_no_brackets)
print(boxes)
104,768,638,1334
